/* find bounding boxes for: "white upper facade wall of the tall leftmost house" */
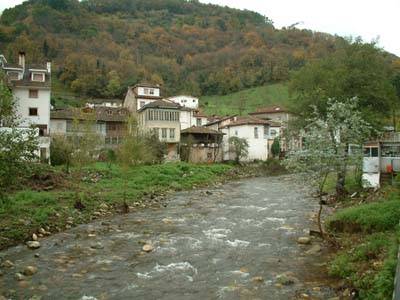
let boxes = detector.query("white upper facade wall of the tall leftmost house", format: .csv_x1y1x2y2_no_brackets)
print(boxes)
13,87,50,128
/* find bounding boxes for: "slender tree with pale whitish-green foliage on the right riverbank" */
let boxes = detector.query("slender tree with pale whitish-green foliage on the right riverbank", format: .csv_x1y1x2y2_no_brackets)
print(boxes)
285,99,371,237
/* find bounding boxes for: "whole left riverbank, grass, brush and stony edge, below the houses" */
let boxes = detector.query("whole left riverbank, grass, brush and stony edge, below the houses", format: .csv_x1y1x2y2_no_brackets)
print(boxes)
0,162,281,249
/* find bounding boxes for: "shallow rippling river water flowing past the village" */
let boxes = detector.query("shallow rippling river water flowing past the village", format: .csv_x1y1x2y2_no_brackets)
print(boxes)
0,176,334,300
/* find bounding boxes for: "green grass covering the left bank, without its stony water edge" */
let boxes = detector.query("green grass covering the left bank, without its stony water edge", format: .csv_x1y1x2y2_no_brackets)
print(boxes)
0,162,233,249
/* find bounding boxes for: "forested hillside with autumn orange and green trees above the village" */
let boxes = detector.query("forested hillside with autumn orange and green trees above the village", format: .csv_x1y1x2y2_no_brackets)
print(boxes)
0,0,347,97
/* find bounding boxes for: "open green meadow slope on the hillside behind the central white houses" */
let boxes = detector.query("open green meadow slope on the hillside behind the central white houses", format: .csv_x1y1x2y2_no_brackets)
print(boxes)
200,83,289,115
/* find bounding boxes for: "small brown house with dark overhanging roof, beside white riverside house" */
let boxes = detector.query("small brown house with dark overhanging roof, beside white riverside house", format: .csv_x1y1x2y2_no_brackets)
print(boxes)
181,126,223,163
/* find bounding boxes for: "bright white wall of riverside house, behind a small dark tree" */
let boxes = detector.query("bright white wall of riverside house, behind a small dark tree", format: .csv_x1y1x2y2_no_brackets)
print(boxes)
222,125,268,161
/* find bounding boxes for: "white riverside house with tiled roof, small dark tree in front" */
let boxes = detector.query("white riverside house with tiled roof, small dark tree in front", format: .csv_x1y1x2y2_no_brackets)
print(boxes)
220,117,281,161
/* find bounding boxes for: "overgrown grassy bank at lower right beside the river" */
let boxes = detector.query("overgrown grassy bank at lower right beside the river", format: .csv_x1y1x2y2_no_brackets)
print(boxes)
327,186,400,299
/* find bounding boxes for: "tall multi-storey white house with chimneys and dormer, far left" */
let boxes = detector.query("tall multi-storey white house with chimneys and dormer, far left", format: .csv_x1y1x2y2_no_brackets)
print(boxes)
0,52,51,161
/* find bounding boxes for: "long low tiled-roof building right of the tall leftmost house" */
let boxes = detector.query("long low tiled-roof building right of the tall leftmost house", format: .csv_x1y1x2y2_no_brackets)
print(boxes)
50,107,129,148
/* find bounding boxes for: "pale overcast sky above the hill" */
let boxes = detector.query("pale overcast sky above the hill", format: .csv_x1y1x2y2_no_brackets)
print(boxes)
0,0,400,56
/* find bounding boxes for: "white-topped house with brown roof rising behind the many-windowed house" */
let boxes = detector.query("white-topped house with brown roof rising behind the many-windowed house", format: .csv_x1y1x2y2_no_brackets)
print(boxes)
123,83,162,114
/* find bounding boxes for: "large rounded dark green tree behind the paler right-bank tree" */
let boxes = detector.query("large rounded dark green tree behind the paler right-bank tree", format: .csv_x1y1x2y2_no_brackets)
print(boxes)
290,40,395,124
